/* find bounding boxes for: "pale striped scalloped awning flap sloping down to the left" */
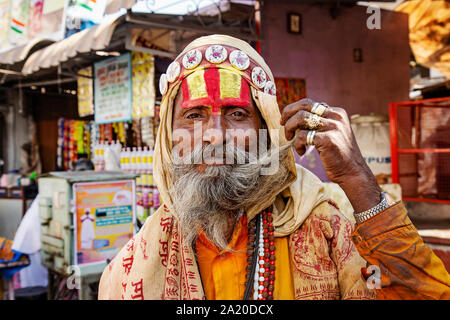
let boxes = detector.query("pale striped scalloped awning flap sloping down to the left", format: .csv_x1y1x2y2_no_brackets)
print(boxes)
22,16,124,75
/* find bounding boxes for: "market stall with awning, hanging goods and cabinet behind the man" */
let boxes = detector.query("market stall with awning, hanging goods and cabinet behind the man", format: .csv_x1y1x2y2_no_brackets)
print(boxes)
0,5,258,299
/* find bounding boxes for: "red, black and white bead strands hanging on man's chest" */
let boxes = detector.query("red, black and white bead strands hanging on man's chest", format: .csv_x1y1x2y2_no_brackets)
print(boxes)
244,210,275,300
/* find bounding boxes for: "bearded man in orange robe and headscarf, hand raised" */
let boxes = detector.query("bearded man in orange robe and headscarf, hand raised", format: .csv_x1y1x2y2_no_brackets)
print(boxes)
99,35,450,300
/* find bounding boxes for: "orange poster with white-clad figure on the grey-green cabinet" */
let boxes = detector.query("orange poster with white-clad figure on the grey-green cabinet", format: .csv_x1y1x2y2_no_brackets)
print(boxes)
73,180,135,265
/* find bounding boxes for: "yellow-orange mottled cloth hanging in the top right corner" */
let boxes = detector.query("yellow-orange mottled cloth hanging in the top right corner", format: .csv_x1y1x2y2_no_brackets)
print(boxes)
395,0,450,77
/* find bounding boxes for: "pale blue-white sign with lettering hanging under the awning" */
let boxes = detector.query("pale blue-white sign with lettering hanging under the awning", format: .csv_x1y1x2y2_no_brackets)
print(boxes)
94,53,132,124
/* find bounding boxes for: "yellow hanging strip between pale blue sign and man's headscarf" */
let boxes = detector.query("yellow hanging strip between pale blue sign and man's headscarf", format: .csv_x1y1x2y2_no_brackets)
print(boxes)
131,52,155,119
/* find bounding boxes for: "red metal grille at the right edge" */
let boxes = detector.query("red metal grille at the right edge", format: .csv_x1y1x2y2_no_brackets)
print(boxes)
389,97,450,203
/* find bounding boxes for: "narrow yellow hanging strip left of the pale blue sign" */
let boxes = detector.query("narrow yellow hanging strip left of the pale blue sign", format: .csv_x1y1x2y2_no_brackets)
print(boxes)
77,67,94,117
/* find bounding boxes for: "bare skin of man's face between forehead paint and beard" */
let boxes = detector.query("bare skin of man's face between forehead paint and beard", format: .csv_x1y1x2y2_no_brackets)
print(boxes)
172,79,263,168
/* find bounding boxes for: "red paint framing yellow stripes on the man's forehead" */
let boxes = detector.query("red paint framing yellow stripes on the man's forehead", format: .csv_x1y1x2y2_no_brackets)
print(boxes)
181,68,250,112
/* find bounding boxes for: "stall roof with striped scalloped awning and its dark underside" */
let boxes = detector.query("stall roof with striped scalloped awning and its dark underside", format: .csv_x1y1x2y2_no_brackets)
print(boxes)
21,6,259,76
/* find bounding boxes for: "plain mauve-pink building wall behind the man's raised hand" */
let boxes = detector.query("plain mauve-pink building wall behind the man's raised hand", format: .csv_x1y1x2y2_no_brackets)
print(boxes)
261,1,410,114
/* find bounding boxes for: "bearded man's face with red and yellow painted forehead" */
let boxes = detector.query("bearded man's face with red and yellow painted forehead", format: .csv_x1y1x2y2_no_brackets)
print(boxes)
170,69,288,250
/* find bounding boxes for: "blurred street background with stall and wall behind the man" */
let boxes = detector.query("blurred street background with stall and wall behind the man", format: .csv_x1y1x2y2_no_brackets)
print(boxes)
0,0,450,300
